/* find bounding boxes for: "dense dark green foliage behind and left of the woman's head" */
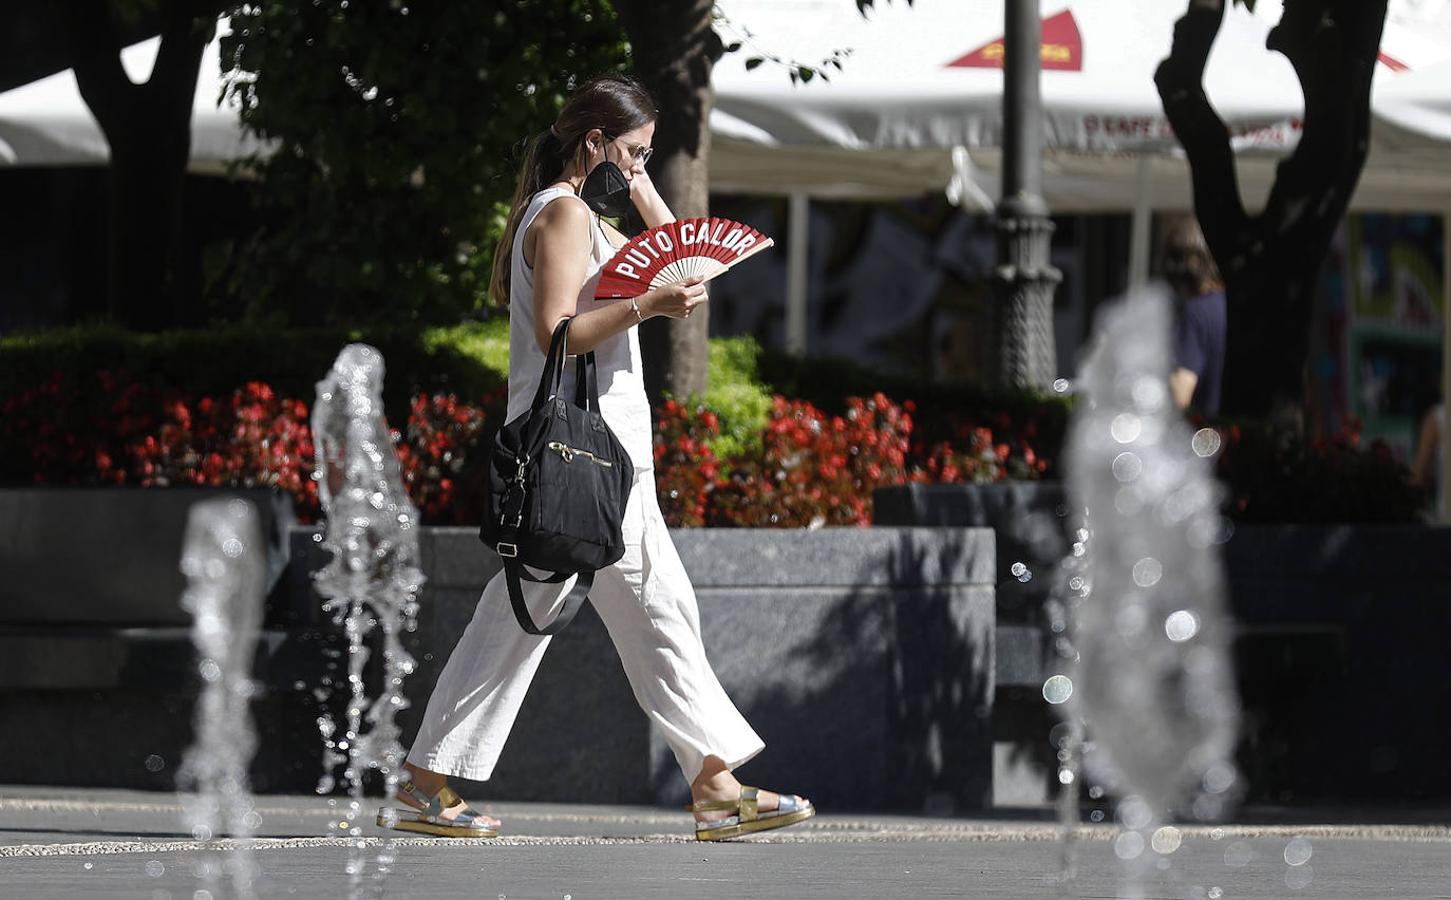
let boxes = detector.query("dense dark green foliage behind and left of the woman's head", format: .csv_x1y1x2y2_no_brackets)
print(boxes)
217,0,628,325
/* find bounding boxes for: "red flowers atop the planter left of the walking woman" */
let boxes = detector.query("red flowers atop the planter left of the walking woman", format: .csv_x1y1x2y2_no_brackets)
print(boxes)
0,372,496,524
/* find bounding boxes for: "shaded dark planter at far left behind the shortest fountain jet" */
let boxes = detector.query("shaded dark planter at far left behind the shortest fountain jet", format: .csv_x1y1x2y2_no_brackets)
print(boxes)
0,488,325,790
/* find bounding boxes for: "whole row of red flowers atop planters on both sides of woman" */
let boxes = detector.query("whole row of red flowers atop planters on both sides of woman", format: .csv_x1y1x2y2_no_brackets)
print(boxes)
11,372,1426,528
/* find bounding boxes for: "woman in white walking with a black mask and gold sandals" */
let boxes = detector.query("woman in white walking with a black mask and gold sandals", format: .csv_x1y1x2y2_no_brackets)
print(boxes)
379,75,815,840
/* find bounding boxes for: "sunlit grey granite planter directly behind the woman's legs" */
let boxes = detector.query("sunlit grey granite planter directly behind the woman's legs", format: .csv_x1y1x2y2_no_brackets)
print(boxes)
325,528,994,811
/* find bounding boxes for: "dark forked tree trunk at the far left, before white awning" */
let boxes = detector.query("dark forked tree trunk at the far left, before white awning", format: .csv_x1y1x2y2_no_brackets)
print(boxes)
67,0,215,331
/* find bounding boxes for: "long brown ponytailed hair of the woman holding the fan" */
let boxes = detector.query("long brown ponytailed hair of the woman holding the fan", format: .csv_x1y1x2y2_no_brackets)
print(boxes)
489,74,659,303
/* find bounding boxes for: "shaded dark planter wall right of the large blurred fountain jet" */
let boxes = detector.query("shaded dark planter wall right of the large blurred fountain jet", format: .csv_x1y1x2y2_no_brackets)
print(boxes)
1225,525,1451,803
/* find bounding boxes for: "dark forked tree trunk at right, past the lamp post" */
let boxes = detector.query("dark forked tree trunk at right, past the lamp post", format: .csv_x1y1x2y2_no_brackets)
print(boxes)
1155,0,1386,417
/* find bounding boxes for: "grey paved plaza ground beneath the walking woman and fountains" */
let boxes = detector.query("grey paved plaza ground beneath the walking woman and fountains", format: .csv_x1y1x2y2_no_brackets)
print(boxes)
0,787,1451,900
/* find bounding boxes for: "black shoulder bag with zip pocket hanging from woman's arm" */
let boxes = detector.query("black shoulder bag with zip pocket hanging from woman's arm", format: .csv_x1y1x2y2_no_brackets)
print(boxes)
479,319,634,634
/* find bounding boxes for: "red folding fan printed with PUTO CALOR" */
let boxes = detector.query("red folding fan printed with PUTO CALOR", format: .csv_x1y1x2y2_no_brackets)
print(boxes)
595,216,773,300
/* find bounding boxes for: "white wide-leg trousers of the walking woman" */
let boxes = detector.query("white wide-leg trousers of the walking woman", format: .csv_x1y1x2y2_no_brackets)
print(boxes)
408,472,765,781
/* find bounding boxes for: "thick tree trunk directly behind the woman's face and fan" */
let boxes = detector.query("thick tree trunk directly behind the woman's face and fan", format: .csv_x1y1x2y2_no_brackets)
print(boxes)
614,0,721,398
